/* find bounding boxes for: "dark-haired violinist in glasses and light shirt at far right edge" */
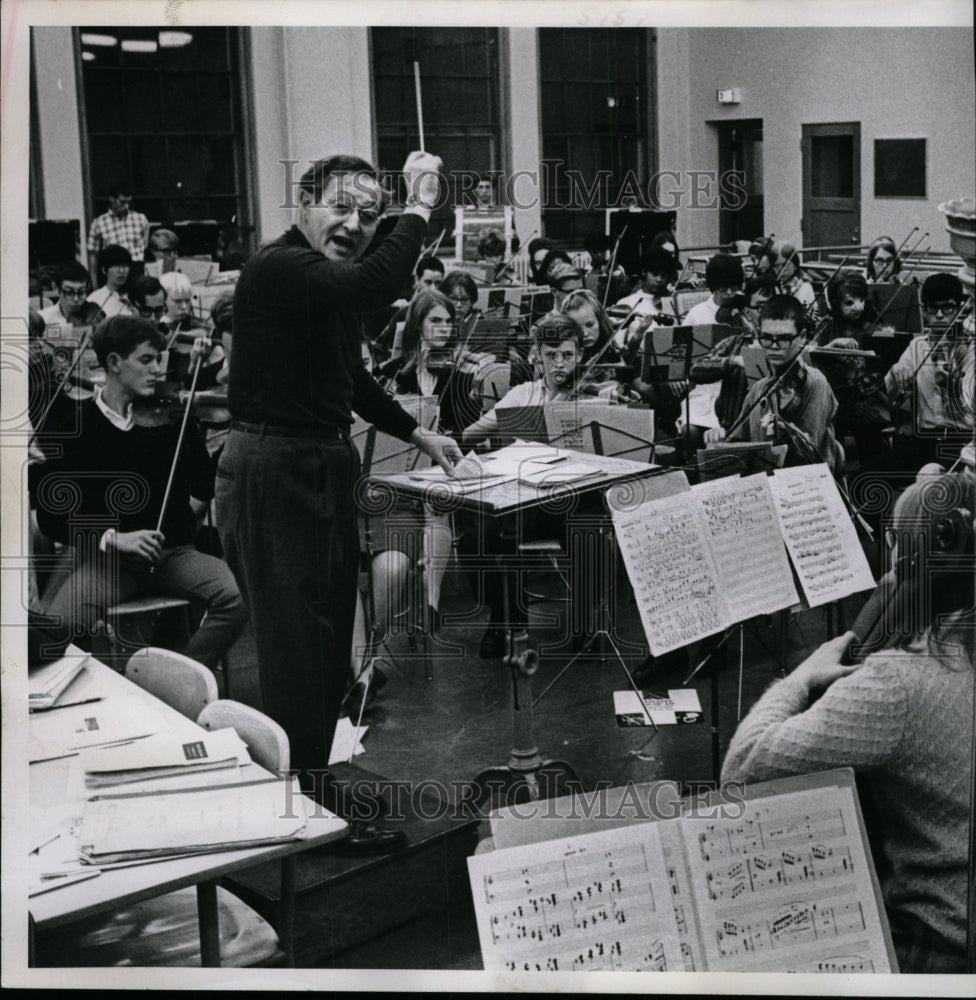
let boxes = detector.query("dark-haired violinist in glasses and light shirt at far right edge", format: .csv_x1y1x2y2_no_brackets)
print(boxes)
885,274,973,471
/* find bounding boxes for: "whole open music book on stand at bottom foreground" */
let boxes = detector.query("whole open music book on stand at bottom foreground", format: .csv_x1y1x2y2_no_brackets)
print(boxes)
468,770,895,973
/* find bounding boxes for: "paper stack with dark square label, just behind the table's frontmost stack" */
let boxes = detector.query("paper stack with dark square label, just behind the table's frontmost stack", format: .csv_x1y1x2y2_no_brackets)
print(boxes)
80,729,251,788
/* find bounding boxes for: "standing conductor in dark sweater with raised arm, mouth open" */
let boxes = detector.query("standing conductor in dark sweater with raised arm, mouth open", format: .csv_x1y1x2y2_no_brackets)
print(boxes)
216,152,461,854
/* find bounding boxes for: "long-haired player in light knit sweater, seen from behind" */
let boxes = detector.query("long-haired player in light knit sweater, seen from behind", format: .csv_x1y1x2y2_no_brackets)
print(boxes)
722,474,976,973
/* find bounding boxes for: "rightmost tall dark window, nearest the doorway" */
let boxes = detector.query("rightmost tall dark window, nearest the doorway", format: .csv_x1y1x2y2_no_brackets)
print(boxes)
539,28,649,242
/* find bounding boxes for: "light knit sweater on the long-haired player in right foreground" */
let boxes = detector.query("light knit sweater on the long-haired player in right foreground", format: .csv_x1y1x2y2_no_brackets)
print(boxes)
722,649,974,949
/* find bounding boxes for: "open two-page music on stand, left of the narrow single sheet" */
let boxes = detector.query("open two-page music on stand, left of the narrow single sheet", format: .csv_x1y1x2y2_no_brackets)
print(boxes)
613,474,798,656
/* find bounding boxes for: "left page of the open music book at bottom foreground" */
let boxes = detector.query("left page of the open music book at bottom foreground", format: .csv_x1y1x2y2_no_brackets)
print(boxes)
468,823,685,972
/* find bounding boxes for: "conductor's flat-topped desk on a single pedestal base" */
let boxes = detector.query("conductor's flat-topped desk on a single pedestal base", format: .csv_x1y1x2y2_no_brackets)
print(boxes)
367,444,668,805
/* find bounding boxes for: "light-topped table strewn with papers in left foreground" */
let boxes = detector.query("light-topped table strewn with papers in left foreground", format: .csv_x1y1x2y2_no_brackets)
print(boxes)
29,659,346,966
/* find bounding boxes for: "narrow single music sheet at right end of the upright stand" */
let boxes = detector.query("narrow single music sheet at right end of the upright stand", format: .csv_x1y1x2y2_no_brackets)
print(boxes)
769,465,874,607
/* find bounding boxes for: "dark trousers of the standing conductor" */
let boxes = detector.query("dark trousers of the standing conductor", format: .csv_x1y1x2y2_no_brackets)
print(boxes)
217,430,360,805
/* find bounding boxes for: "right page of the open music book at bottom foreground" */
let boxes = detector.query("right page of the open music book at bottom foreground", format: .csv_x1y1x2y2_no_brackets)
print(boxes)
679,786,891,973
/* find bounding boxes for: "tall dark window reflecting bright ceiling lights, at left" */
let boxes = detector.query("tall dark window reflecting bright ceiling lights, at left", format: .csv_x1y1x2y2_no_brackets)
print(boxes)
76,27,250,232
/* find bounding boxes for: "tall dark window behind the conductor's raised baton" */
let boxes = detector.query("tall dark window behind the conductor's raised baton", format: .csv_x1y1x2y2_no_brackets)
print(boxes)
370,28,502,237
